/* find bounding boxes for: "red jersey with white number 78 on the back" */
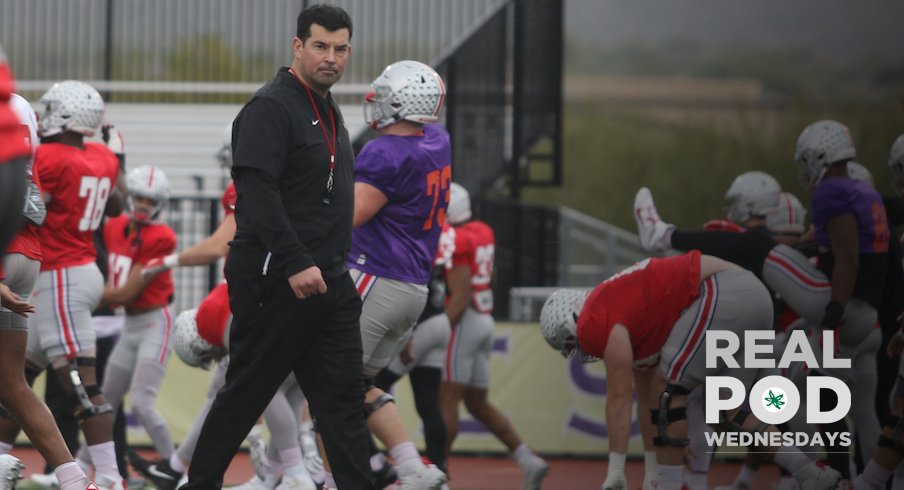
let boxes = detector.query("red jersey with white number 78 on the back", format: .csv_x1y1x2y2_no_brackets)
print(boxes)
34,143,119,271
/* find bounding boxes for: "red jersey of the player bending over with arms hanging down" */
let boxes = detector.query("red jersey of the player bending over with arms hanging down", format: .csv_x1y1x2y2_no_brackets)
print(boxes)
578,250,700,364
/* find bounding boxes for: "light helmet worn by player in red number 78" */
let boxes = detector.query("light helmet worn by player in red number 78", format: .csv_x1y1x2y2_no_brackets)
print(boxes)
38,80,104,136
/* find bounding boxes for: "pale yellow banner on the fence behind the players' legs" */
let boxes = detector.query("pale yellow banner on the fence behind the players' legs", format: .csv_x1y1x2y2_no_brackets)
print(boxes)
20,323,642,456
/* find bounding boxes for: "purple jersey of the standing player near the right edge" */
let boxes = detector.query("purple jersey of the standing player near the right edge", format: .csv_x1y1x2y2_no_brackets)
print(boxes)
813,178,889,254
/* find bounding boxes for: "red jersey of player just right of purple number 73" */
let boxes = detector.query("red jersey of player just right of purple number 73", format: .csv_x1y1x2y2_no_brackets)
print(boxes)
452,221,496,314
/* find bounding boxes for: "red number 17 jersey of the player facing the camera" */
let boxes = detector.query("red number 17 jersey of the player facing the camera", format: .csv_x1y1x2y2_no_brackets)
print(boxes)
104,213,176,309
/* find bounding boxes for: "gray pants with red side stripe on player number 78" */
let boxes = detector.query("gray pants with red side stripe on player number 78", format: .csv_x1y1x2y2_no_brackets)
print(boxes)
27,262,104,368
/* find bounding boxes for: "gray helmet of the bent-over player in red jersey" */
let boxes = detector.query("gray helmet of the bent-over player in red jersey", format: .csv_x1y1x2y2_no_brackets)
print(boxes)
540,289,590,357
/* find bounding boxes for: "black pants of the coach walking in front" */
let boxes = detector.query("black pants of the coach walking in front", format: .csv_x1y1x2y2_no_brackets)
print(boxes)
183,243,375,490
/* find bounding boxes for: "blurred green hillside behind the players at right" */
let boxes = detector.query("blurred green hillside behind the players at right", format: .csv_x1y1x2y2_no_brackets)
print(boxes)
524,100,904,230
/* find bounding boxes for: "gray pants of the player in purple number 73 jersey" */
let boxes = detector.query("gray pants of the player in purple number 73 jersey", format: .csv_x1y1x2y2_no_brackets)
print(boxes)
351,269,427,378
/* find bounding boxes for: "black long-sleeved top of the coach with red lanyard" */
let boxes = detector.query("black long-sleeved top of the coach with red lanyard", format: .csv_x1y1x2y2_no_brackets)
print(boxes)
230,67,355,277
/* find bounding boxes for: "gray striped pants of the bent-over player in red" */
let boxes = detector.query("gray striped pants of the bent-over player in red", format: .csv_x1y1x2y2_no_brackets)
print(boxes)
659,270,773,388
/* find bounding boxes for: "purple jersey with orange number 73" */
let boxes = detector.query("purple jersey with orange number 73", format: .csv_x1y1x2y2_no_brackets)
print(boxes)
348,125,452,284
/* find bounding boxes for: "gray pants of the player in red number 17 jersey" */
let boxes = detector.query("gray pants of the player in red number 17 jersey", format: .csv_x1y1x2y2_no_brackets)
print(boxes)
107,306,173,371
